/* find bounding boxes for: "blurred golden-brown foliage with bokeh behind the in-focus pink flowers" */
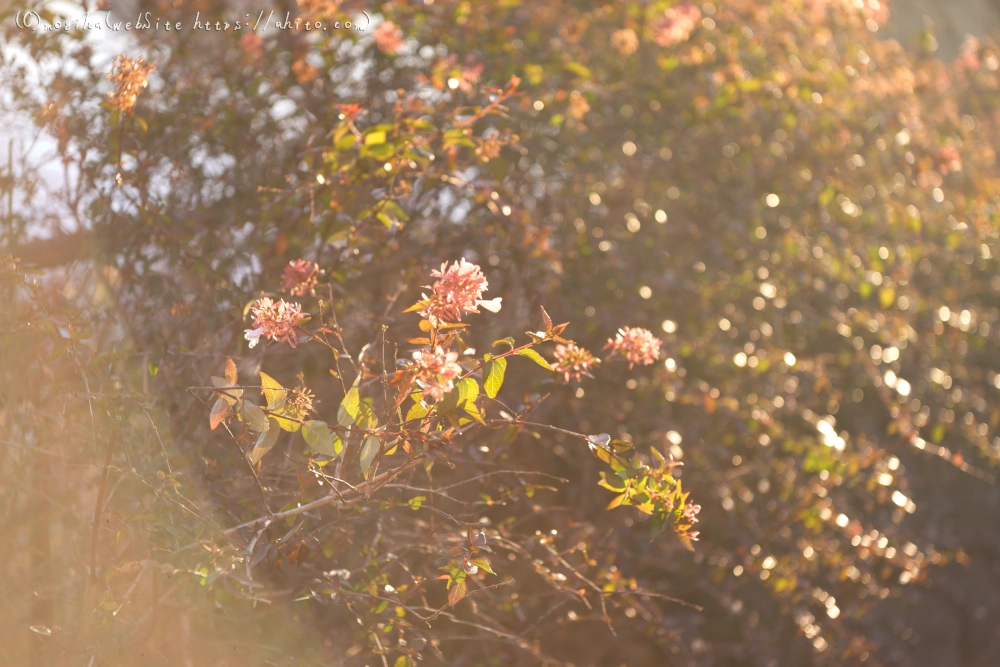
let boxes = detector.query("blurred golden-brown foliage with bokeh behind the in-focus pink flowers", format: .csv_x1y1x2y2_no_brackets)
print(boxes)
0,0,1000,667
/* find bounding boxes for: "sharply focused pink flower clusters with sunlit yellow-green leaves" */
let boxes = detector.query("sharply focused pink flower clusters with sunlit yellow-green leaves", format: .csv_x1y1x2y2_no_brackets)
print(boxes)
210,259,699,560
